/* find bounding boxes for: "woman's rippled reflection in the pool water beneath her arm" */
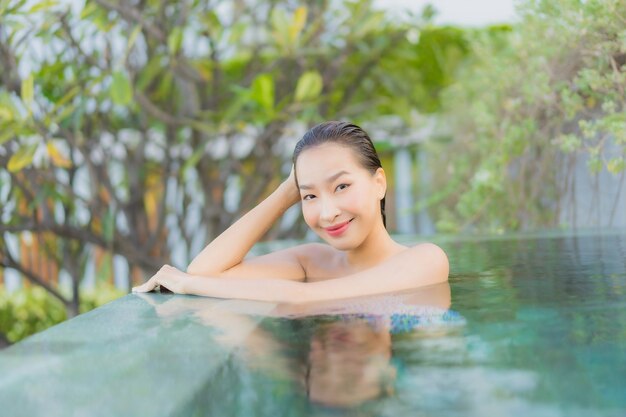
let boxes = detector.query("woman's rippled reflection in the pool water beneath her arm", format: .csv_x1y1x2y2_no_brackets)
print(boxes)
137,283,459,408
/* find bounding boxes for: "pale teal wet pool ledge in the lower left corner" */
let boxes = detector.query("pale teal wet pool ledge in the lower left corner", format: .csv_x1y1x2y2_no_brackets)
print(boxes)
0,294,254,417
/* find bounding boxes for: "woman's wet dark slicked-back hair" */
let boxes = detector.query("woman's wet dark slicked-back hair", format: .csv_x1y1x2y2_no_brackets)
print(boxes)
293,121,387,227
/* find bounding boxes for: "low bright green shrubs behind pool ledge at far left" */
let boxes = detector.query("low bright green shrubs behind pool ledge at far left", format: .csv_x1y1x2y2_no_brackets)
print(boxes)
0,284,124,343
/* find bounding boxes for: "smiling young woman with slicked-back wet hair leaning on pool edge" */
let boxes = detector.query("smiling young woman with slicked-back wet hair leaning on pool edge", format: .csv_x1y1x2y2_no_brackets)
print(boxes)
133,122,449,303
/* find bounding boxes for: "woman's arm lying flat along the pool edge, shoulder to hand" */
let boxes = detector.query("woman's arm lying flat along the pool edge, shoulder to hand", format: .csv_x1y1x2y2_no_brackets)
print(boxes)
133,243,449,303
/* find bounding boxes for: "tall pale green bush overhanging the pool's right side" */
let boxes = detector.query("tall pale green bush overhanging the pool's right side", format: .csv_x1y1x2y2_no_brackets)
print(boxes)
433,0,626,232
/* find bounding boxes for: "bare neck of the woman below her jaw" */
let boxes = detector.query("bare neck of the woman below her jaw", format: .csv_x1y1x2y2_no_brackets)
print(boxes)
345,223,406,271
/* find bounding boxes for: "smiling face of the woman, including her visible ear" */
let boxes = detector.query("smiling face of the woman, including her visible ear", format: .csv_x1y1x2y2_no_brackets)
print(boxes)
296,143,387,250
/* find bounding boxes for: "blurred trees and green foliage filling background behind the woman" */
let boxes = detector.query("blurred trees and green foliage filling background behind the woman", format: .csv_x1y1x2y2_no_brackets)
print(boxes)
0,0,626,343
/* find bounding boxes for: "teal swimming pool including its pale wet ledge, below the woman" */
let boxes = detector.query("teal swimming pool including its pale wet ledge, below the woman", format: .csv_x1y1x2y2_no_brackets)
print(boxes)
0,232,626,417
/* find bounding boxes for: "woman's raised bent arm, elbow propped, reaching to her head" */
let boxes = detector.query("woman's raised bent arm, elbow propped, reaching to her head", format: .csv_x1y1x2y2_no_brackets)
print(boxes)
187,172,305,281
